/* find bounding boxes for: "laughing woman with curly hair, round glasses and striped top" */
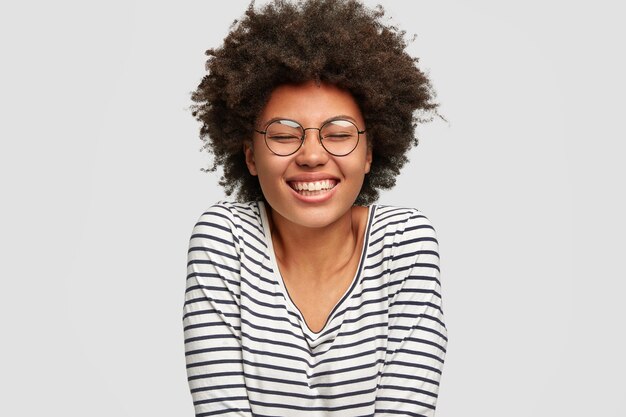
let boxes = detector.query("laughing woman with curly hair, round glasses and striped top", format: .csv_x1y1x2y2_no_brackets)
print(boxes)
184,0,447,417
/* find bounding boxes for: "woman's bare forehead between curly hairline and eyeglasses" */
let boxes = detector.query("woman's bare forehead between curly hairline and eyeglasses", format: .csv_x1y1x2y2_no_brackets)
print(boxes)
259,81,363,126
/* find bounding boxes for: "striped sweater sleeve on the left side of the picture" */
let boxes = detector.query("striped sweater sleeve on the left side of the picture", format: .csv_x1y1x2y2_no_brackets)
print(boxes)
183,203,251,417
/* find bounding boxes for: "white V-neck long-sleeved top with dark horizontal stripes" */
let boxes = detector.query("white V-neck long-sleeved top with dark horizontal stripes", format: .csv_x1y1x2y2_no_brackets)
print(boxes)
183,202,447,417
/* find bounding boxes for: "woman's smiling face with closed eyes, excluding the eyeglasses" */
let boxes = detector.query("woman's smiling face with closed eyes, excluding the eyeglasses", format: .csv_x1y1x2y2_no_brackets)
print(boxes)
244,82,372,231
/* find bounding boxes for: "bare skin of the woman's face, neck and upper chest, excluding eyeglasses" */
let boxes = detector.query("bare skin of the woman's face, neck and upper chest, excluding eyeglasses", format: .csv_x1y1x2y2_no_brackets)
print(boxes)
244,82,372,332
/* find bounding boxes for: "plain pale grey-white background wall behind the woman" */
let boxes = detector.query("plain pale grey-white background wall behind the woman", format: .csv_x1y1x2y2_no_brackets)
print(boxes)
0,0,626,417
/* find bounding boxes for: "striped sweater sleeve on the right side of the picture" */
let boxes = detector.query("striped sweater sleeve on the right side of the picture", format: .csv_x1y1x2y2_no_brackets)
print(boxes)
375,212,448,417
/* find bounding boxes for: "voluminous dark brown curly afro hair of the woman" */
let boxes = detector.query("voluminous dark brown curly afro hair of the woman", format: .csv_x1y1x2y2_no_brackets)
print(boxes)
191,0,437,205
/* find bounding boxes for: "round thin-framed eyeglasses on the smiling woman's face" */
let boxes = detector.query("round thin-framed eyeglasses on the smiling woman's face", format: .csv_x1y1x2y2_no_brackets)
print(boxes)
255,119,365,156
